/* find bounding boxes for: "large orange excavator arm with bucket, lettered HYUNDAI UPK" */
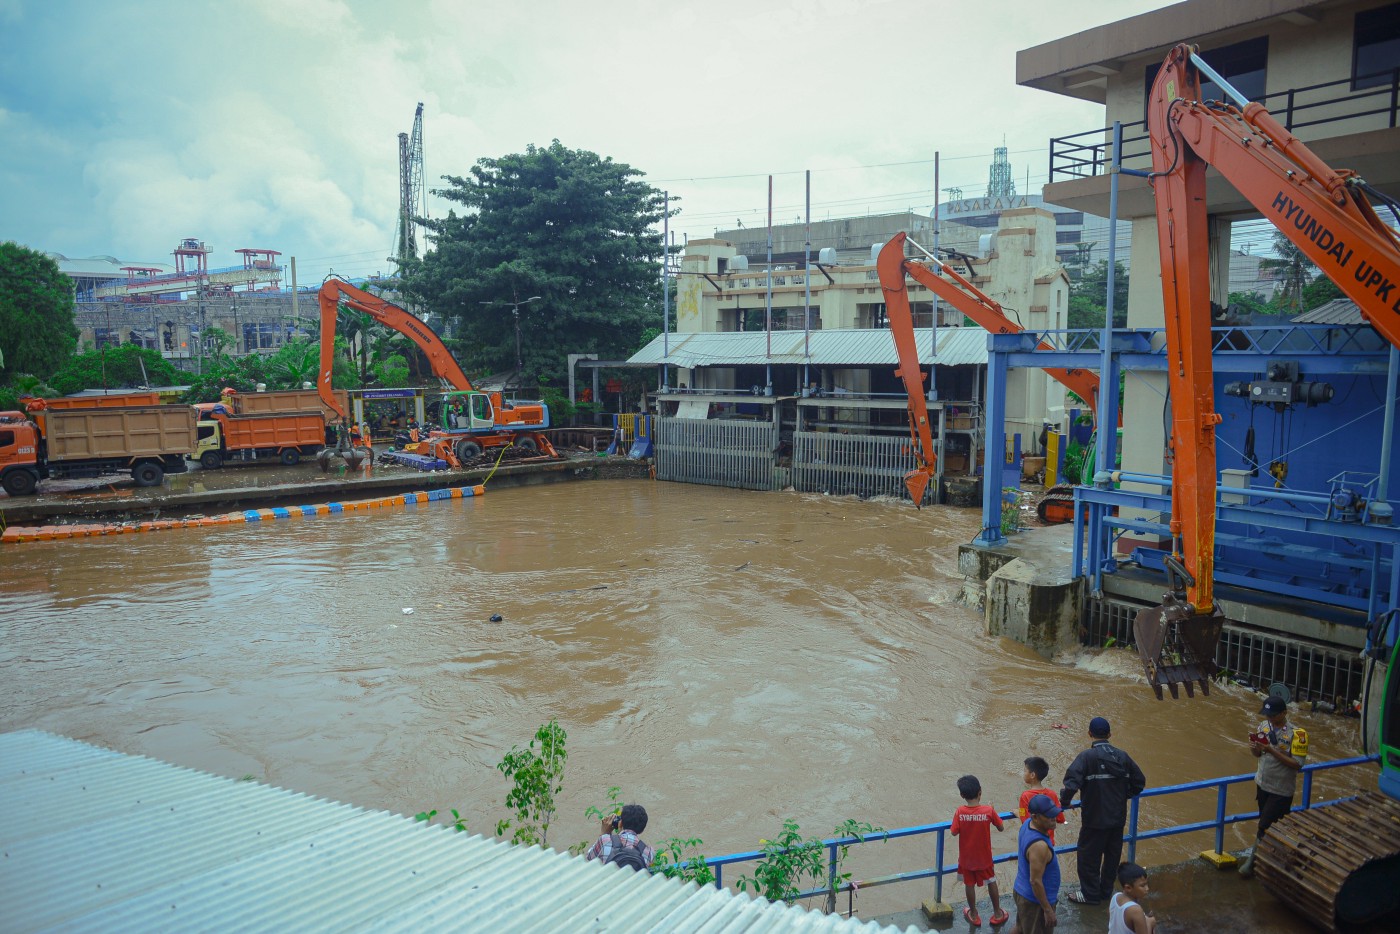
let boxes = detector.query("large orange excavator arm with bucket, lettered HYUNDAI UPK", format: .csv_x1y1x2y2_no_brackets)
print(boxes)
1134,45,1400,697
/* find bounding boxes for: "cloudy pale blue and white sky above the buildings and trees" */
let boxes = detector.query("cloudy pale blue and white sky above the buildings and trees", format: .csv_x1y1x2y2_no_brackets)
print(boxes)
0,0,1168,284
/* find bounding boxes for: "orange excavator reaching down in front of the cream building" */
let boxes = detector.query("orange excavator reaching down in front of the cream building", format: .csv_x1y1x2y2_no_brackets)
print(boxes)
875,232,1099,522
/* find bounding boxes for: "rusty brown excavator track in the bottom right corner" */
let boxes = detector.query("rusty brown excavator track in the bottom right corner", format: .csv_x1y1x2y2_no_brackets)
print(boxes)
1254,791,1400,931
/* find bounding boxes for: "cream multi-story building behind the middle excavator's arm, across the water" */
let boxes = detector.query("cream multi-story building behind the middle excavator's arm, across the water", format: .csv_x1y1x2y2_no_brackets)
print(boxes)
676,201,1070,435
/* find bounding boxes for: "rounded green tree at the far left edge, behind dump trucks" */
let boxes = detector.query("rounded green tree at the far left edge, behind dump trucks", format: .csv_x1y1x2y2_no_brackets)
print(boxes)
0,241,78,381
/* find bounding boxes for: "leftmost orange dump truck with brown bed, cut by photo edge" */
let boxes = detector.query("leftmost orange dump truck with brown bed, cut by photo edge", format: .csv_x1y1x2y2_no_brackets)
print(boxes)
0,400,195,496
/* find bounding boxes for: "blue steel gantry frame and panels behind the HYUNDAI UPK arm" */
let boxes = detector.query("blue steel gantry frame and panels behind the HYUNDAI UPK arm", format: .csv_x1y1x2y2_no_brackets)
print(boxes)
973,323,1400,632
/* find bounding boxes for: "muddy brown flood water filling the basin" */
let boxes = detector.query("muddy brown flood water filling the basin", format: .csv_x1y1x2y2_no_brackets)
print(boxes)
0,480,1375,930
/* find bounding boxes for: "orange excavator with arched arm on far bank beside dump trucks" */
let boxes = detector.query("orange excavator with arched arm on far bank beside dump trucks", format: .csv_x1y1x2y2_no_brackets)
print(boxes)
316,276,559,469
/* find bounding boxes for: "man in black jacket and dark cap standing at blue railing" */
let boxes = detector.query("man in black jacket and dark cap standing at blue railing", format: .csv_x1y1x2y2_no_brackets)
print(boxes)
1060,717,1147,905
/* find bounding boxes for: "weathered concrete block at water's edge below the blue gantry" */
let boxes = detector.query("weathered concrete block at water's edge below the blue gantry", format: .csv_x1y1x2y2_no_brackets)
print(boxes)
987,557,1085,658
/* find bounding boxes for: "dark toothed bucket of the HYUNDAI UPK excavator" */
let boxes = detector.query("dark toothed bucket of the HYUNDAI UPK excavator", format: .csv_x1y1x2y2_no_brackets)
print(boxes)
1133,594,1225,700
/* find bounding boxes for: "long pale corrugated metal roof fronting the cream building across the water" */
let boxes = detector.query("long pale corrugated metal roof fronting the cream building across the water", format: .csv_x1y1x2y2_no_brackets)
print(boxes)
627,328,987,370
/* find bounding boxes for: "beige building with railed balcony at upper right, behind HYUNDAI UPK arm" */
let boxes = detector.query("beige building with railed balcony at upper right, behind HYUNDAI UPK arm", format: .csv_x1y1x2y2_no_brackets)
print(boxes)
1016,0,1400,492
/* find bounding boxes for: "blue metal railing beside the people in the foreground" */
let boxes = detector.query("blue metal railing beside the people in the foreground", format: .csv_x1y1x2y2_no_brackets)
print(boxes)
706,755,1380,902
